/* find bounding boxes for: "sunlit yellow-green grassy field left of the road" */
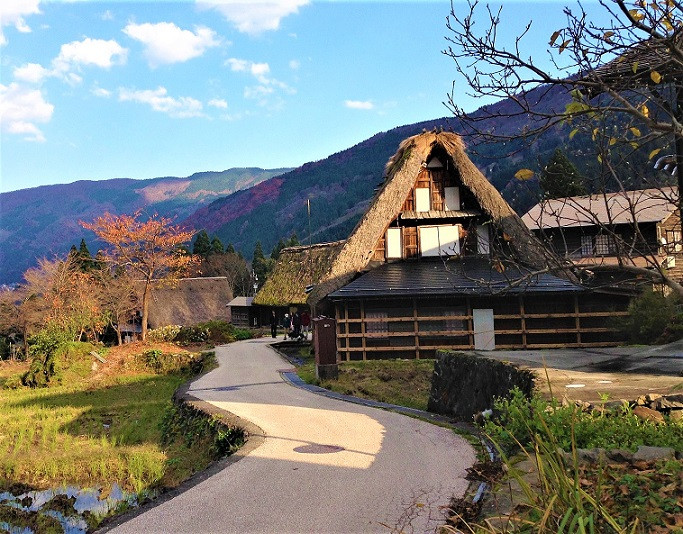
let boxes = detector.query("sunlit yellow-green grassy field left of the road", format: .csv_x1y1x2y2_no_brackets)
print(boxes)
0,343,235,493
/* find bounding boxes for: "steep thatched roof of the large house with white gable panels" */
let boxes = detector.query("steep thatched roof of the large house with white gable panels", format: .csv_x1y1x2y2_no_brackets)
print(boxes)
309,132,562,305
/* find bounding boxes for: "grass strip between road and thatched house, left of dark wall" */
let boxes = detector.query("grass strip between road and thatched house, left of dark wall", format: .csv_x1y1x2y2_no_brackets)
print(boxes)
297,354,434,410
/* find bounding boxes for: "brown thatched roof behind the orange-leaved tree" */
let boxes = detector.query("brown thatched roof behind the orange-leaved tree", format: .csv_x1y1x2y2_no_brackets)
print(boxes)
144,276,232,328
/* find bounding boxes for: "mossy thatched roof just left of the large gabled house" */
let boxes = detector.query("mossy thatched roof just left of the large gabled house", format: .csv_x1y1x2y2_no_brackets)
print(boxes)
254,241,345,306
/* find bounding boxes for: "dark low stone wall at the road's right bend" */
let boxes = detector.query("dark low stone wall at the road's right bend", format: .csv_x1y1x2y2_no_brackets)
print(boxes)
427,351,535,421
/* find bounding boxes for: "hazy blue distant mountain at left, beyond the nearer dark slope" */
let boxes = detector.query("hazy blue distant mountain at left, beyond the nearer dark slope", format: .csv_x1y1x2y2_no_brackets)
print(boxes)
0,168,289,283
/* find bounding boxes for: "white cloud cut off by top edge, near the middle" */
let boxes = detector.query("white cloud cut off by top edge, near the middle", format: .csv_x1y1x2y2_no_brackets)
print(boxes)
197,0,309,35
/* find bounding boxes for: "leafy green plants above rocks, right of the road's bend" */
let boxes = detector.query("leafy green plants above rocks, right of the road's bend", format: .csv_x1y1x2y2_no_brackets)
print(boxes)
485,388,683,452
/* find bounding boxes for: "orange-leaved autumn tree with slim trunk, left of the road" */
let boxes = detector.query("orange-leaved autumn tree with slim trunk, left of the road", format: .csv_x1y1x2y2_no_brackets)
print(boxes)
81,210,194,340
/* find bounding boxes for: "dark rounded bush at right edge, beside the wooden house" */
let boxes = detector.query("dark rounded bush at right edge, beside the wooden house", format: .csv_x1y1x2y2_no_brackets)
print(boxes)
616,291,683,345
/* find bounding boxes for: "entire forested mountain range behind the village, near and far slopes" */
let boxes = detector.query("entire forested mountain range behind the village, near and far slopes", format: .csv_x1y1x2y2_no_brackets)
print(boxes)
0,84,662,283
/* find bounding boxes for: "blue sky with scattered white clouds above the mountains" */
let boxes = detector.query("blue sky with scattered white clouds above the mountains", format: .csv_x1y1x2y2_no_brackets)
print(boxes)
0,0,592,195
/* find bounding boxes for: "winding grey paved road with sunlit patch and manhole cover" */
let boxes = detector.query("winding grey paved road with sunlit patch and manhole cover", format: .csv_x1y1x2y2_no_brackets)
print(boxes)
113,340,475,533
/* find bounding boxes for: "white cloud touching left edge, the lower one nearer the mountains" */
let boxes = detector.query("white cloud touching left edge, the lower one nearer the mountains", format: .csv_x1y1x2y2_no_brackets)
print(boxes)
0,82,54,142
